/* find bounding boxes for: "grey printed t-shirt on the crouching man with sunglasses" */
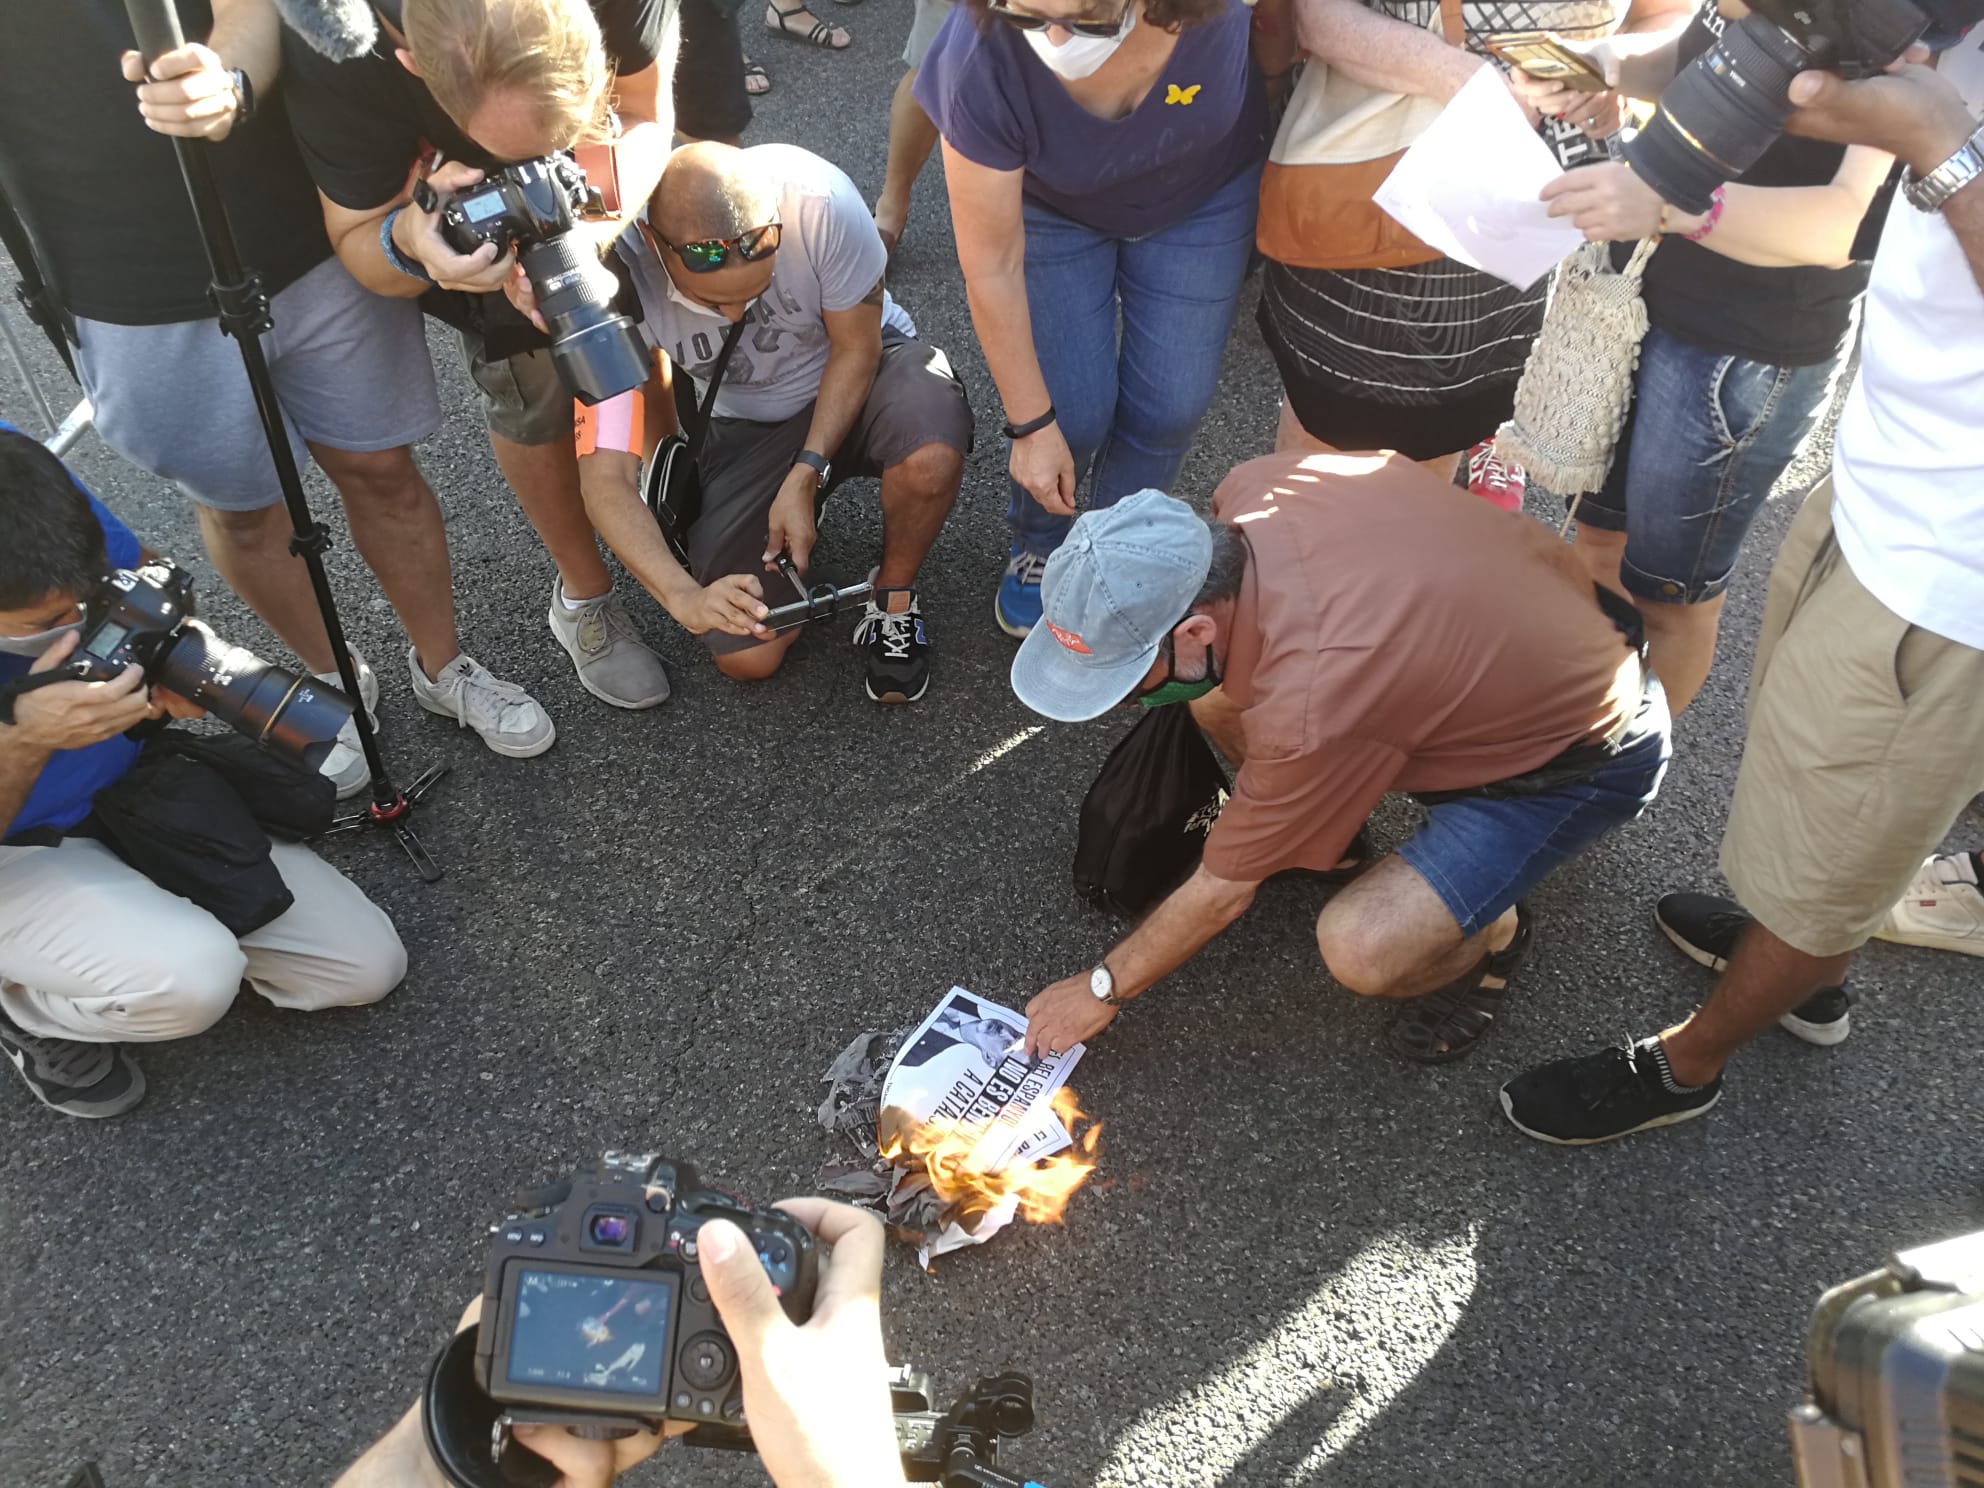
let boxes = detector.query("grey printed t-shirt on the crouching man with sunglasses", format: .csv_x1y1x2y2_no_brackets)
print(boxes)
619,145,917,423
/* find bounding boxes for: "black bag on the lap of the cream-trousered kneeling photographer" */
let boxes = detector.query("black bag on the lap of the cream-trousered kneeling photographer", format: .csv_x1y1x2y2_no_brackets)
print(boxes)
83,728,337,936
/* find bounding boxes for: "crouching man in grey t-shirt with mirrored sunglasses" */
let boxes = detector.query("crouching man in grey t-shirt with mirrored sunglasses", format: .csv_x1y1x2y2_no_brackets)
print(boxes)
579,143,972,702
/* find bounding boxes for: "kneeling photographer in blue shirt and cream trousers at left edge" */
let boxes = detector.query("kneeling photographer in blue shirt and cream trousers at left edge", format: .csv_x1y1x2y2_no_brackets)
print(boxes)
0,425,407,1117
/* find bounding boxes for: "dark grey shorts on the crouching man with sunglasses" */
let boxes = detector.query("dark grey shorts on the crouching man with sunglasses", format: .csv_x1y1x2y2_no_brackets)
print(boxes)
688,337,972,653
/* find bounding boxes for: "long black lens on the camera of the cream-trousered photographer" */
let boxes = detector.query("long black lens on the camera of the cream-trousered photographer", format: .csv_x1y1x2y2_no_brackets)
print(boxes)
156,619,353,772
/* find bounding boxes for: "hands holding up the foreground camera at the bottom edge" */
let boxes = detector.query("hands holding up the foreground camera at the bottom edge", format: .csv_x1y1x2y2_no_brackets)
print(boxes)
335,1184,905,1488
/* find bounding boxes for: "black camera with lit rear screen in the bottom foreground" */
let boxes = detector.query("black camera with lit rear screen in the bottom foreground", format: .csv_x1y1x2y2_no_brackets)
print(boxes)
421,1151,1034,1488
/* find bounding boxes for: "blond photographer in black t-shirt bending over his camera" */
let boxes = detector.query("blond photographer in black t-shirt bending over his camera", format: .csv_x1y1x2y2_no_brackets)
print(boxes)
284,0,677,734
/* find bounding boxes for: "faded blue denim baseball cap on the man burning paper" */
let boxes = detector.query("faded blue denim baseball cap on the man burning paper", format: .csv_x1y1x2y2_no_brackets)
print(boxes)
1012,490,1212,724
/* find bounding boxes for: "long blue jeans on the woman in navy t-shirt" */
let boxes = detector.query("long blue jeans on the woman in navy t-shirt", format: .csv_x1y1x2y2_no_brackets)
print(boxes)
1006,167,1260,558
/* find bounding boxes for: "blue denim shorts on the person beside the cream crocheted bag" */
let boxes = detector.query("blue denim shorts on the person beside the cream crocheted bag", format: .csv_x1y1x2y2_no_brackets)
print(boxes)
1577,329,1841,605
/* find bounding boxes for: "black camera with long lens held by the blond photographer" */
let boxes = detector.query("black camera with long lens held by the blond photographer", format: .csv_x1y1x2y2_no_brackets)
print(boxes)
415,155,649,405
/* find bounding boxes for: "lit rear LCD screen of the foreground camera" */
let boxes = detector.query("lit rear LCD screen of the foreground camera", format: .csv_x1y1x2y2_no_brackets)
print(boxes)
506,1270,675,1397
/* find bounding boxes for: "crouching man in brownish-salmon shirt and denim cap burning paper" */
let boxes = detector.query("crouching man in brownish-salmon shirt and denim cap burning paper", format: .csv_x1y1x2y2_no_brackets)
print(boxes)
1012,454,1671,1063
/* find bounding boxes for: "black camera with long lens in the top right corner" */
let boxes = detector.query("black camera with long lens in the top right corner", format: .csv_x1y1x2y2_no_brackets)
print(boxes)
1625,0,1984,212
